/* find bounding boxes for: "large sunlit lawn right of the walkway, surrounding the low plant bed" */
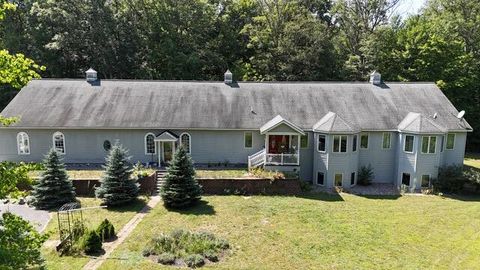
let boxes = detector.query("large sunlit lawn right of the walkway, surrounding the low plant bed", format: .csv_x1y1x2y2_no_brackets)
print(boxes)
101,194,480,270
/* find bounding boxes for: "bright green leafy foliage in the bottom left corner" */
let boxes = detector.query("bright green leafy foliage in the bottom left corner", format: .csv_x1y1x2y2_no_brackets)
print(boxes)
0,212,47,270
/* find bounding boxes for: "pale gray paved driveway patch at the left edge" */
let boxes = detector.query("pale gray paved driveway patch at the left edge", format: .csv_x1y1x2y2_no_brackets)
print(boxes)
0,203,50,232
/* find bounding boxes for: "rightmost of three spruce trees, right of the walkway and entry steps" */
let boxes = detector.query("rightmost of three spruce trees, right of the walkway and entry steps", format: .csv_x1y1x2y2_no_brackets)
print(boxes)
160,147,202,208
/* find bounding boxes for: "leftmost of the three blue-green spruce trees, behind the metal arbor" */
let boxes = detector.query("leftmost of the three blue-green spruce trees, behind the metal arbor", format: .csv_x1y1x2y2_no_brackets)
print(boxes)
32,149,75,209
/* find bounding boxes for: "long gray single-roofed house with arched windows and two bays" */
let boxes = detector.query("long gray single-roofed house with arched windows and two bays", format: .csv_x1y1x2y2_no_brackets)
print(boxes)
0,70,472,189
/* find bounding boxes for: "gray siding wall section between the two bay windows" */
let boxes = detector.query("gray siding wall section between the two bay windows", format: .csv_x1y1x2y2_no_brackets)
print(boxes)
358,132,398,183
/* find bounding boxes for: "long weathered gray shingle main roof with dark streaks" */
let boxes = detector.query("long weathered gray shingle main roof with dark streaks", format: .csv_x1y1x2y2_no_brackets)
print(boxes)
2,79,470,130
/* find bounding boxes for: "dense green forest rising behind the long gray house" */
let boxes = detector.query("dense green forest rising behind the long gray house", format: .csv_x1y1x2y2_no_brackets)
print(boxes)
0,0,480,152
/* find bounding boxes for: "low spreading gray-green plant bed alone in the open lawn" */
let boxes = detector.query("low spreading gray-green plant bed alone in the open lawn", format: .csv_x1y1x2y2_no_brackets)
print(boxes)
143,229,230,267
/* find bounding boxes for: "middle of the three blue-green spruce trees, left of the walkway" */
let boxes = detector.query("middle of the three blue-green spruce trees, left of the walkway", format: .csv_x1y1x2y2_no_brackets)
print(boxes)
95,144,139,205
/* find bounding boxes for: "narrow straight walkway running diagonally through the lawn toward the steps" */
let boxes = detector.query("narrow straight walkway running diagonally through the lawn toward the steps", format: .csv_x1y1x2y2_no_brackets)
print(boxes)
83,196,160,270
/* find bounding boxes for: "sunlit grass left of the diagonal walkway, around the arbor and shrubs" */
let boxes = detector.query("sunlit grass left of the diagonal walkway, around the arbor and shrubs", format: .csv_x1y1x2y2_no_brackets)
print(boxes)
42,197,147,270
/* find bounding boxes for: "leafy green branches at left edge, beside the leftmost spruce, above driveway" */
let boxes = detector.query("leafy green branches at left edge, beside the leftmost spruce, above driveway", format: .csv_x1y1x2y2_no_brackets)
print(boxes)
0,161,41,199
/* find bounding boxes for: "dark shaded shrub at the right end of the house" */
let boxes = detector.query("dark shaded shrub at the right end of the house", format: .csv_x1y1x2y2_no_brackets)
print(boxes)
432,165,465,193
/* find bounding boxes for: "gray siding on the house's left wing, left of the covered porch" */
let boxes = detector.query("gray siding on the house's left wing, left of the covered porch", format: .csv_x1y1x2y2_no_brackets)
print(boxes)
0,129,265,164
